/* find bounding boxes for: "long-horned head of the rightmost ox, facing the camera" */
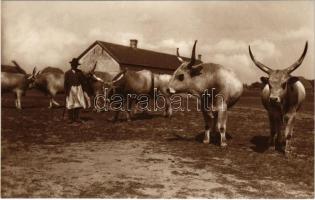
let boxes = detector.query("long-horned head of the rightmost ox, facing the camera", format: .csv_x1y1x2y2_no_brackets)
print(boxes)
248,42,308,105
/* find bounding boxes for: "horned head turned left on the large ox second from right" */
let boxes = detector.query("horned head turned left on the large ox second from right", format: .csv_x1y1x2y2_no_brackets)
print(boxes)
168,40,202,94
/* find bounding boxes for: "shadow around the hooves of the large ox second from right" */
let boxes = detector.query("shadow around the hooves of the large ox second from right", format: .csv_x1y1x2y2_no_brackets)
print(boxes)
167,132,232,146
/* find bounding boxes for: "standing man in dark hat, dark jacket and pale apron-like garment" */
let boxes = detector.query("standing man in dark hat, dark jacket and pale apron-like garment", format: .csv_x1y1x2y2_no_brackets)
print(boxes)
64,58,89,123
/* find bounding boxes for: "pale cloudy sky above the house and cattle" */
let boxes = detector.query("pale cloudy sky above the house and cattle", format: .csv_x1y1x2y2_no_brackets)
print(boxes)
1,1,314,82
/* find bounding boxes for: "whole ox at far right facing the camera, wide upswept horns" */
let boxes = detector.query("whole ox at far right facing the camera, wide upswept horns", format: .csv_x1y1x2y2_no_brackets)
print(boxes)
248,42,308,154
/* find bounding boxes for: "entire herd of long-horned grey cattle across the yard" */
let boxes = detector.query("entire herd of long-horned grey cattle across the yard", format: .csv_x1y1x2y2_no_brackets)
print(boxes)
1,41,308,154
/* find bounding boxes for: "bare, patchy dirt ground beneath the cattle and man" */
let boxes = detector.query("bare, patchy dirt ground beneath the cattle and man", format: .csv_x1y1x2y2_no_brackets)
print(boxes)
1,91,314,198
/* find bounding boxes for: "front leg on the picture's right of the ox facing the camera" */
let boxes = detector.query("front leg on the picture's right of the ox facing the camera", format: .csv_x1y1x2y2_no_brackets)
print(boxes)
284,112,296,154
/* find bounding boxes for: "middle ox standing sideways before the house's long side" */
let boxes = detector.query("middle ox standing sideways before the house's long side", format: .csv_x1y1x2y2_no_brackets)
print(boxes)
110,70,172,121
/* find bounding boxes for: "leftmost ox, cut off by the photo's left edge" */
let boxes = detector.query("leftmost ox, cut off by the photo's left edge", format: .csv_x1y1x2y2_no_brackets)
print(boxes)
1,61,36,109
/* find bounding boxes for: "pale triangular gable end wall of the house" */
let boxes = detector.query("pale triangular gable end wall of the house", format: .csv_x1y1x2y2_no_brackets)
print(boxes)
80,44,120,74
